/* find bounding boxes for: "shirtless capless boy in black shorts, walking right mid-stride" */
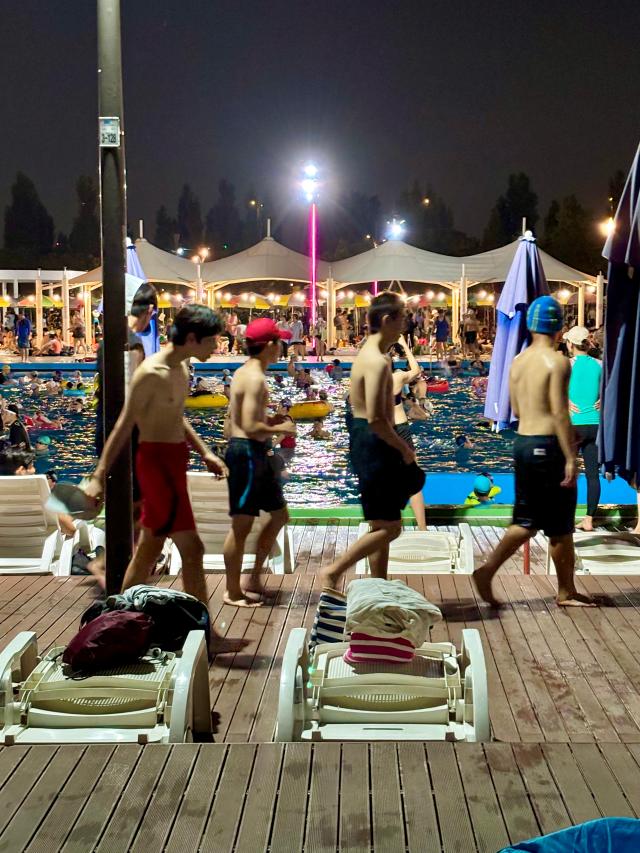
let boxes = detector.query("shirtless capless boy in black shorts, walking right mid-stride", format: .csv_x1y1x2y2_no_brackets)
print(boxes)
324,292,424,589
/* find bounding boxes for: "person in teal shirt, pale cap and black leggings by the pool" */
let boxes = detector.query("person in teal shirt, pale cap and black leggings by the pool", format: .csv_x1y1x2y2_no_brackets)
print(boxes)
563,326,602,530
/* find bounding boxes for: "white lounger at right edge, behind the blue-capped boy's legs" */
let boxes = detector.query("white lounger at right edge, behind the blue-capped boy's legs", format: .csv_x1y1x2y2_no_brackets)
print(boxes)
545,530,640,575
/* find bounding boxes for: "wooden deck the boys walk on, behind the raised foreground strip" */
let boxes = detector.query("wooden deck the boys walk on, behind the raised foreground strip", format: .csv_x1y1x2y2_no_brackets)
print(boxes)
0,525,640,744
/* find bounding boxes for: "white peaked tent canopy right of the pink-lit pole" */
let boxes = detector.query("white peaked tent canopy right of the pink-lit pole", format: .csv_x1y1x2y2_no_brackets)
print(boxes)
331,240,595,287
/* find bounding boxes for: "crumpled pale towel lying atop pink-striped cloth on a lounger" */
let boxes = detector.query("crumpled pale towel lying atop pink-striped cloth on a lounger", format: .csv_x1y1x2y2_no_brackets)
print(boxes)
345,578,442,648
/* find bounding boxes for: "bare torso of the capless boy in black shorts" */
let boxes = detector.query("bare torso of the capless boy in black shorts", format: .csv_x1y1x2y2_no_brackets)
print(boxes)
350,337,394,424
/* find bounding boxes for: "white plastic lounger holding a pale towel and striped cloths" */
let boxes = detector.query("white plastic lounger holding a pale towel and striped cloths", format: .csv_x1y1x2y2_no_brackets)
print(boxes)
276,628,491,742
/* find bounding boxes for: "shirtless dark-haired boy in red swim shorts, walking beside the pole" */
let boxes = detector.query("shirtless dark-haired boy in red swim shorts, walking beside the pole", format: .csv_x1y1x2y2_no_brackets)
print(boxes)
85,305,244,651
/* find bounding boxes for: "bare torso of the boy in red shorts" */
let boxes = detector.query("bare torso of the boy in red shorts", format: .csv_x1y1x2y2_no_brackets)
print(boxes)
127,352,189,444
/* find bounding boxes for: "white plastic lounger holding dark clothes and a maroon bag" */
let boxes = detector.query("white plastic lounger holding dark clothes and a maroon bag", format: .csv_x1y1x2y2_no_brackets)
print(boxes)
0,631,211,746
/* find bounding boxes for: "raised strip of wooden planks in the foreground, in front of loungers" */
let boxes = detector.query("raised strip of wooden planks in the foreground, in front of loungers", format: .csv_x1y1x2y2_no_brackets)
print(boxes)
0,743,640,853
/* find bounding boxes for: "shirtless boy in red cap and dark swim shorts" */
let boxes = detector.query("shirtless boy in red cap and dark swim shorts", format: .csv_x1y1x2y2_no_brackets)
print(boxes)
224,318,296,607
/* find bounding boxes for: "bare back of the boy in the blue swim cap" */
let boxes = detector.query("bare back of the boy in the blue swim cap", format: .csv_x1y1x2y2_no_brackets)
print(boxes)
509,346,571,435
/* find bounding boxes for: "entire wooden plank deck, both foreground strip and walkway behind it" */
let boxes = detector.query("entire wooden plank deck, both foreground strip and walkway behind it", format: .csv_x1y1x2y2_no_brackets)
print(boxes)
0,525,640,853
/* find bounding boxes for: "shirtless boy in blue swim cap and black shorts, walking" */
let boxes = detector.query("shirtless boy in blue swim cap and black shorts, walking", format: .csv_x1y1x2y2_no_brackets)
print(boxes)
473,296,595,607
